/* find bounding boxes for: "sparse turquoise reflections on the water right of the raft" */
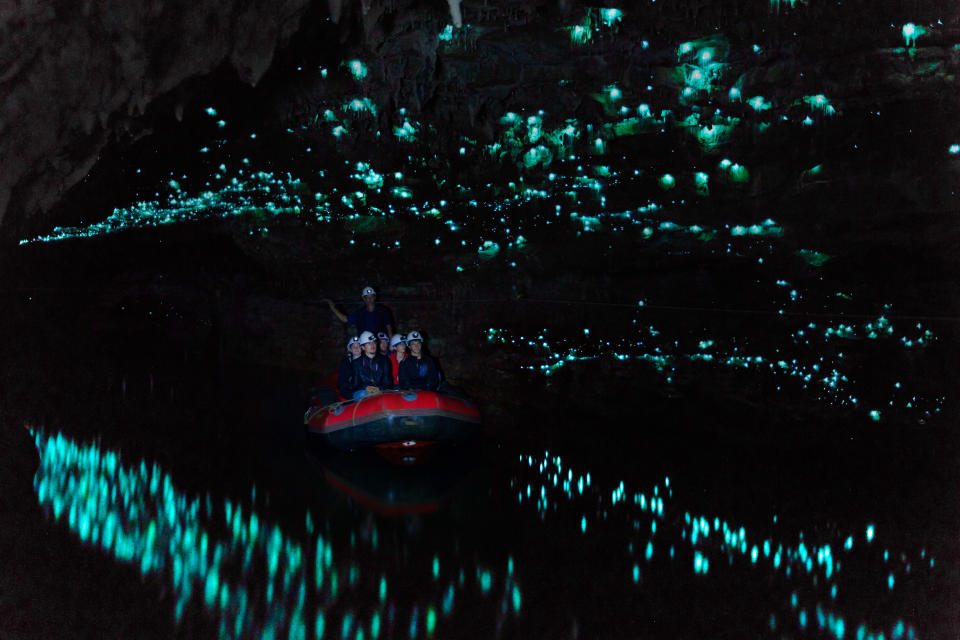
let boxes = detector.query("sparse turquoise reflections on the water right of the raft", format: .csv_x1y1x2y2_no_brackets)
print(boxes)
511,452,924,640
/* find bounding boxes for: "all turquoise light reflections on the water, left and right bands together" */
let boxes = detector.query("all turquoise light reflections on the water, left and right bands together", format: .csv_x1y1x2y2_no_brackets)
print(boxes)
33,431,939,639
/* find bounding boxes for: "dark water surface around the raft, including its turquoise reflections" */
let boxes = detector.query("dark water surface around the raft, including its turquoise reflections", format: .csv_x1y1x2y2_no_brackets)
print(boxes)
0,276,960,639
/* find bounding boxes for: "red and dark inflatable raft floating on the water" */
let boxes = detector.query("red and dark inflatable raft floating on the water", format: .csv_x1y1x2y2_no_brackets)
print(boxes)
303,391,480,450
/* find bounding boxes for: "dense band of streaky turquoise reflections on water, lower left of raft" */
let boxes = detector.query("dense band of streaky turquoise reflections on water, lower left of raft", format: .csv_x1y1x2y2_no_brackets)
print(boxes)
33,431,522,639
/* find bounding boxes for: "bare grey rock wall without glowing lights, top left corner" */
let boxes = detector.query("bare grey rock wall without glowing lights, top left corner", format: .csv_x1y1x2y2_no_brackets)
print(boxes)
0,0,309,242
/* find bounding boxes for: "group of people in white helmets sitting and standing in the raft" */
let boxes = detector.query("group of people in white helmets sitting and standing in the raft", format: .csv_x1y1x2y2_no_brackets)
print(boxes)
327,287,442,399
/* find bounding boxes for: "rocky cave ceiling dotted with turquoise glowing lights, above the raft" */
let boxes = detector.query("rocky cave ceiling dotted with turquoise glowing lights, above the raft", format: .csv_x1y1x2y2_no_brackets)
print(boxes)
0,0,960,246
